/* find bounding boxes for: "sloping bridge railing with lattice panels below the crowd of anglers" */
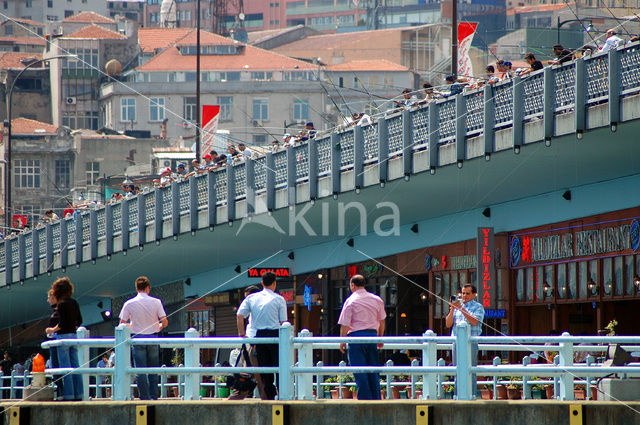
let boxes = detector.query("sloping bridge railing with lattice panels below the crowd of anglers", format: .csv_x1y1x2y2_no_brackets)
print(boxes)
0,43,640,284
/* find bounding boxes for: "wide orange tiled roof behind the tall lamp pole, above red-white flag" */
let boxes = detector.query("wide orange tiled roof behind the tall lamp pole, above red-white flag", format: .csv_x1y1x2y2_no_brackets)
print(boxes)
136,30,315,72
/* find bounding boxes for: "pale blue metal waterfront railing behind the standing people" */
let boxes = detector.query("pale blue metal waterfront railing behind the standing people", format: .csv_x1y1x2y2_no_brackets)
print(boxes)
33,323,640,400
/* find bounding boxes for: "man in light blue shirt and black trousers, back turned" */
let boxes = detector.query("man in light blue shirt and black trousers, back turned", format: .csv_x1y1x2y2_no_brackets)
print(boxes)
237,272,287,400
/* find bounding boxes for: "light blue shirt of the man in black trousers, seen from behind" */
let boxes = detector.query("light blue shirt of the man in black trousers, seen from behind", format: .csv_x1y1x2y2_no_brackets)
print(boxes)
237,288,287,335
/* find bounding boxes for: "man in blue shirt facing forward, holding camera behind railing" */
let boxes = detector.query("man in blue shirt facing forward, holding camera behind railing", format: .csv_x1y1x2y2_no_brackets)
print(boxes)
446,284,484,394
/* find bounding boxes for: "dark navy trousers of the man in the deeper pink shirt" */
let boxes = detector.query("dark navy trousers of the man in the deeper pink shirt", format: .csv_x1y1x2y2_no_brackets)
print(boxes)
347,329,380,400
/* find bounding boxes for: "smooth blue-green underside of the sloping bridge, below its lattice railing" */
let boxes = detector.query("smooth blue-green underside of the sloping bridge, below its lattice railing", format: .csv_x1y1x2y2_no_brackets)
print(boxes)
0,115,640,328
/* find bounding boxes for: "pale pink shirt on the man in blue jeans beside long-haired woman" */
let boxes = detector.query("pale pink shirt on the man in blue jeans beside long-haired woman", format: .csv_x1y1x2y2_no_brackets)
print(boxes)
120,292,167,335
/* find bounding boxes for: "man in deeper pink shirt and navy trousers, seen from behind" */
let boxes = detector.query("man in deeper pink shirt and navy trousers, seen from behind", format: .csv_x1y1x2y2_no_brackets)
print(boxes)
338,274,387,400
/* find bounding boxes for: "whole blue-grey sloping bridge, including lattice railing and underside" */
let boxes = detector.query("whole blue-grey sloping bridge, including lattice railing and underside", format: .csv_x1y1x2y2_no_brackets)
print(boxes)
0,43,640,328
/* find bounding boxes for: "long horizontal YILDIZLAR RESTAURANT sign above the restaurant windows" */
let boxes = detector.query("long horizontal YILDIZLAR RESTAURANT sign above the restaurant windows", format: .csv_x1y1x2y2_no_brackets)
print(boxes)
509,219,640,268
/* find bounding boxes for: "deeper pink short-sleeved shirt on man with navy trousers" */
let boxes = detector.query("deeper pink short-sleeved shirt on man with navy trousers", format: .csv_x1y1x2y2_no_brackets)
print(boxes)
338,288,387,332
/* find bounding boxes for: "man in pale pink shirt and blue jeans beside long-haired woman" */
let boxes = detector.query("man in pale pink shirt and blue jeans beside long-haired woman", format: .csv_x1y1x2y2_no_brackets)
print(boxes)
120,276,169,400
